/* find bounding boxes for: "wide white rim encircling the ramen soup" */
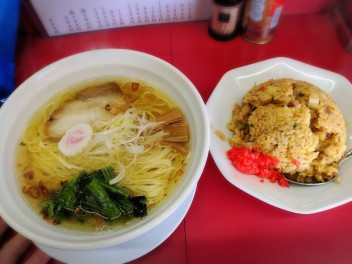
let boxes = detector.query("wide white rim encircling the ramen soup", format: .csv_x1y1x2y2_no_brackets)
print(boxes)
0,49,210,250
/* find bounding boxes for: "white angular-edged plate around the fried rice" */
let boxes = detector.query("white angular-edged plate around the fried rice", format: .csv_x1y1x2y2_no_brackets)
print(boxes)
206,57,352,214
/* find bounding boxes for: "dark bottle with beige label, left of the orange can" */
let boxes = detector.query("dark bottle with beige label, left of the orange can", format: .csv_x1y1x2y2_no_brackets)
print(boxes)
208,0,244,41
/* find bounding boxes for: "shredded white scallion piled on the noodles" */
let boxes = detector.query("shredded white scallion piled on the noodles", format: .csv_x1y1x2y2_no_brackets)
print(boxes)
71,108,164,184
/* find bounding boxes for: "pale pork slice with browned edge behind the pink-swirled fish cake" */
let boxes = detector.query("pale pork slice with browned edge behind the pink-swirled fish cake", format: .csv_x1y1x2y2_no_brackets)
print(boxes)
46,82,130,139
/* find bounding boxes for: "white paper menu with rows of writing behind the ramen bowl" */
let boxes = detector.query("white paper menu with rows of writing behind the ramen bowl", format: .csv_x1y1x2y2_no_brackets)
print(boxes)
29,0,211,36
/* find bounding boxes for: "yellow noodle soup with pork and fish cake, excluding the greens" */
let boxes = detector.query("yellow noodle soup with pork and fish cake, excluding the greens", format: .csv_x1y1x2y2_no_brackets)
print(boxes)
16,77,190,232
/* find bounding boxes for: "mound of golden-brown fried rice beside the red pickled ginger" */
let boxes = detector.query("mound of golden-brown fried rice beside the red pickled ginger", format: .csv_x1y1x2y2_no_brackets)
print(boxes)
228,78,347,182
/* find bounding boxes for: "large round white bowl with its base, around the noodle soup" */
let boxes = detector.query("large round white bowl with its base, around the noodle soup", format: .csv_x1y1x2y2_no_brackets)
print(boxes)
0,49,210,263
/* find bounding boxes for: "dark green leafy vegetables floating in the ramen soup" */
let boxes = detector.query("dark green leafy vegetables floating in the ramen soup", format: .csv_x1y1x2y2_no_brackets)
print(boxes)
42,167,147,223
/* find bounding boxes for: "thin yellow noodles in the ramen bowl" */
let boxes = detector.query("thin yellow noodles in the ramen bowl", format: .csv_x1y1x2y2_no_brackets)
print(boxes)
16,78,187,210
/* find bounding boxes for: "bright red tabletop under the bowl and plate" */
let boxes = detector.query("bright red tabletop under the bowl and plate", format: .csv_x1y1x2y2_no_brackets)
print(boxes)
15,14,352,264
